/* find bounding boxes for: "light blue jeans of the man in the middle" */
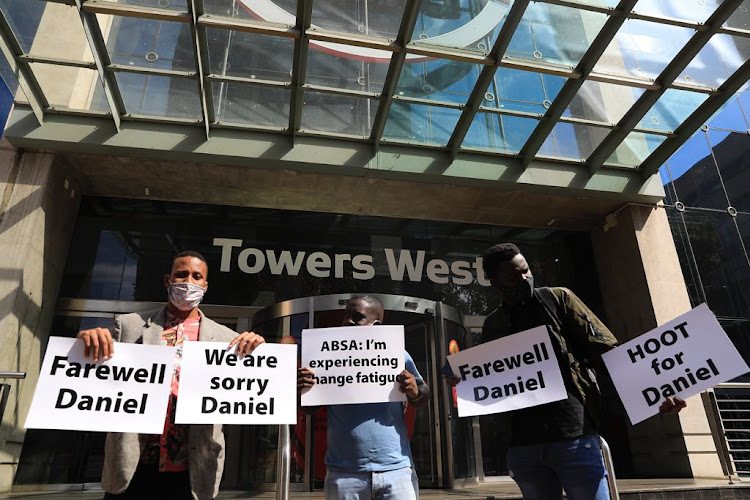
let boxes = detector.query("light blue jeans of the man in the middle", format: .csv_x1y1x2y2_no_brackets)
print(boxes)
325,467,419,500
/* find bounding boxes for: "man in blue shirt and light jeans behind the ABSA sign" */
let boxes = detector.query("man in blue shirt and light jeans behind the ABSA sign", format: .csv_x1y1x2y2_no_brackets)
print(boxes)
297,296,430,500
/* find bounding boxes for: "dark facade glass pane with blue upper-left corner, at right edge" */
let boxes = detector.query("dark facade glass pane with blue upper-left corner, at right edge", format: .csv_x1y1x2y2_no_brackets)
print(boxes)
708,130,750,213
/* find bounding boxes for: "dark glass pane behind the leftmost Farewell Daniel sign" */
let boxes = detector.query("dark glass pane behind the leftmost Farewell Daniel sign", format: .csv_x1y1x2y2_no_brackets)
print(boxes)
14,316,114,485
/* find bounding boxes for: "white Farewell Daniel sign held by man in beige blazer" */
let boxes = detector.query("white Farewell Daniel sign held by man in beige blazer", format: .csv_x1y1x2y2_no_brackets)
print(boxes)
26,337,175,434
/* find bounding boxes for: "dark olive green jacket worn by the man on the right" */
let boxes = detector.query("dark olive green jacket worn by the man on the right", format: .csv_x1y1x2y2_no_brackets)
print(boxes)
482,287,617,425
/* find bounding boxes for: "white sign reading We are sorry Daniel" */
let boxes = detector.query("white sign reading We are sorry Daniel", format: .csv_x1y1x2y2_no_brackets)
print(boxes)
175,342,297,424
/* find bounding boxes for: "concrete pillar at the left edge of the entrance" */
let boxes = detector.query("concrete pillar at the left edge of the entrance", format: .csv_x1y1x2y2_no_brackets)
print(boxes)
0,141,81,492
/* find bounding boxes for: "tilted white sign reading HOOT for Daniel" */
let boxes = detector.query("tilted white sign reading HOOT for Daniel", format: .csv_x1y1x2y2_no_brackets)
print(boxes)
602,304,748,424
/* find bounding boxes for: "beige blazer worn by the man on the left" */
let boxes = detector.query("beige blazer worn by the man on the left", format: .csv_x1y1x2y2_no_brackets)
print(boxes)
102,307,237,500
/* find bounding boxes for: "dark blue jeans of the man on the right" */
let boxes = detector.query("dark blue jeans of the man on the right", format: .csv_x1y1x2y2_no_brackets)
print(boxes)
508,435,609,500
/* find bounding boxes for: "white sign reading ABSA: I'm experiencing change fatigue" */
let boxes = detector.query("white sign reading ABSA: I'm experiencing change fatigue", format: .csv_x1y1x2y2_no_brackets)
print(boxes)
302,325,406,406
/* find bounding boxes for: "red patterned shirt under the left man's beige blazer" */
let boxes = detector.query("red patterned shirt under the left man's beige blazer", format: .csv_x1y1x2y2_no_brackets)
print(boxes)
141,312,201,472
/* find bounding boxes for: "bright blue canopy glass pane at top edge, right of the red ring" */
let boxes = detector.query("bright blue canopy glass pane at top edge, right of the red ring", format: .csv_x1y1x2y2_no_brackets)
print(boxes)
506,2,607,66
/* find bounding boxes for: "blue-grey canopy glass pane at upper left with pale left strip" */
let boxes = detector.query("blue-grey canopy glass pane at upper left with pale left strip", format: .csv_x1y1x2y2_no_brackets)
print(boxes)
102,15,196,71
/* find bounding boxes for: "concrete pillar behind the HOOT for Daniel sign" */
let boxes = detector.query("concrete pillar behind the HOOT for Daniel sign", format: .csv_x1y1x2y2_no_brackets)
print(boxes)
591,205,724,478
